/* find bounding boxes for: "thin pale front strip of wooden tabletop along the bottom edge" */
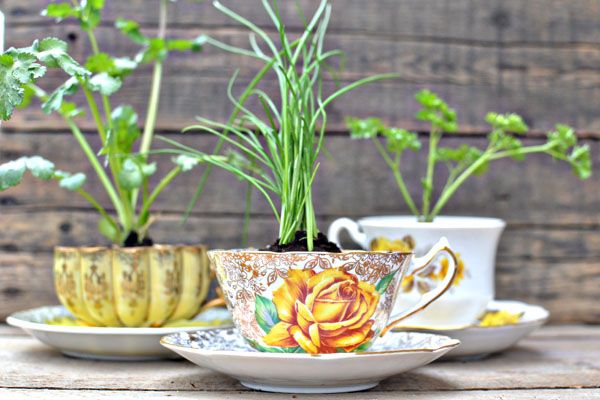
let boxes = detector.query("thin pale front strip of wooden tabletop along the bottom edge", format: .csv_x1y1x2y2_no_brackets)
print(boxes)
0,389,600,400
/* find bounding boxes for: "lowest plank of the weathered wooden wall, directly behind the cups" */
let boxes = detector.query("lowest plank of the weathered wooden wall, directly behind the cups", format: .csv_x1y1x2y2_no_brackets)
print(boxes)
0,210,600,323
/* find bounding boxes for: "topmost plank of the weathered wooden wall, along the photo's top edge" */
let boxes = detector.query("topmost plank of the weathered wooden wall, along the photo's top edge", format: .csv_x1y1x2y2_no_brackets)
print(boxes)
3,0,600,45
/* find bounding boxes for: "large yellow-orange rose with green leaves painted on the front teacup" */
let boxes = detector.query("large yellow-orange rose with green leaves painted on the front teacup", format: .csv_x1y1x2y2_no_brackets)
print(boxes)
256,268,382,354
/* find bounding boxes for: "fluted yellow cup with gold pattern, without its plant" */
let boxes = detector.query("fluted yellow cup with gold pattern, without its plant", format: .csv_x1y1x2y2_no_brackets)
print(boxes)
54,245,216,327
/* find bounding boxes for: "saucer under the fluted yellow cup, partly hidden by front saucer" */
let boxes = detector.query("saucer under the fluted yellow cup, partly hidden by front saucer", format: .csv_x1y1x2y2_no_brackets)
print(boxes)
6,306,231,361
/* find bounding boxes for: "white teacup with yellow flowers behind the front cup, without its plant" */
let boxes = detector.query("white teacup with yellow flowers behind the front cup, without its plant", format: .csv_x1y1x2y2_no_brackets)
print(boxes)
328,216,506,327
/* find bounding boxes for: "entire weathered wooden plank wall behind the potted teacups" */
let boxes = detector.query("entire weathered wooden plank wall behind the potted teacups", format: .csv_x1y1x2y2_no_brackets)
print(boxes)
0,0,600,323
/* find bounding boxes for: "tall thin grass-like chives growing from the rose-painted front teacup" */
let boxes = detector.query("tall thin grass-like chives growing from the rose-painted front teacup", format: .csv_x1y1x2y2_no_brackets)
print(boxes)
164,0,390,251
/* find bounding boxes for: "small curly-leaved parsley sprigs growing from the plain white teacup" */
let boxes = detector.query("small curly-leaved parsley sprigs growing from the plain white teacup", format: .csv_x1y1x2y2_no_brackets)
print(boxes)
346,90,592,222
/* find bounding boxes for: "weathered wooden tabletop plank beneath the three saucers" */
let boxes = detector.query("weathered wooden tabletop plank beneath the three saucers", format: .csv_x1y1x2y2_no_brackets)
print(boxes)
0,331,600,398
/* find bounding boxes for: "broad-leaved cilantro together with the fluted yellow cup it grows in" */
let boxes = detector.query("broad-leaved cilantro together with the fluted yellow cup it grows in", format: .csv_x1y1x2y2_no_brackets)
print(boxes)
0,0,223,326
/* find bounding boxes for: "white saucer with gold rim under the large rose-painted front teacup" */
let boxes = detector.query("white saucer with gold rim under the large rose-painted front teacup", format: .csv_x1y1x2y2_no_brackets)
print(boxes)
161,328,460,393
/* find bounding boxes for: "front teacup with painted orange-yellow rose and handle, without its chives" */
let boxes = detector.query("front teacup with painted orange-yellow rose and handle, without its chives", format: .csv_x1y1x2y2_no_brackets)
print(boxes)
208,238,456,354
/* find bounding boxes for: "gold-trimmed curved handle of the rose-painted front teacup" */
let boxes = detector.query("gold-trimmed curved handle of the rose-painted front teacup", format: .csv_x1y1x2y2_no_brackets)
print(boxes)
380,237,457,336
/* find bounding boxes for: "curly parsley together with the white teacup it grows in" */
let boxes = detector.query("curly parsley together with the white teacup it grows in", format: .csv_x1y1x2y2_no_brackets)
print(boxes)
329,90,591,326
